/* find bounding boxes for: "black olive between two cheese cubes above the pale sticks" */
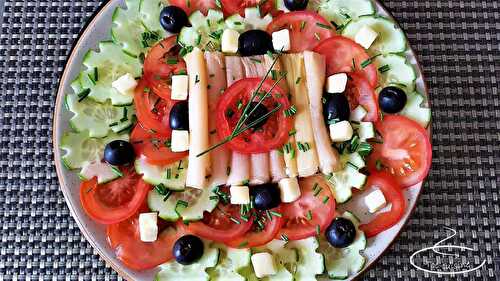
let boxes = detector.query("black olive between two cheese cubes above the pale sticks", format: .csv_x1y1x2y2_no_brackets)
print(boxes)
238,29,273,56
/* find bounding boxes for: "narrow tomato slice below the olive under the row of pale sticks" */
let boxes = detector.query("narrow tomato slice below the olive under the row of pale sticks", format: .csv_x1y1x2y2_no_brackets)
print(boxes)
226,207,283,248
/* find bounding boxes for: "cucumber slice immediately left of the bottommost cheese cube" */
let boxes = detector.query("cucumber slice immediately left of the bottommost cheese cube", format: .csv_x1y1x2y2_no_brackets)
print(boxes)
207,243,251,281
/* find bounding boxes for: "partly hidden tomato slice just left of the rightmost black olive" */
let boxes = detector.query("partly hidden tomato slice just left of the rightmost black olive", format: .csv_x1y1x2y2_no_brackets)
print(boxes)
344,72,379,122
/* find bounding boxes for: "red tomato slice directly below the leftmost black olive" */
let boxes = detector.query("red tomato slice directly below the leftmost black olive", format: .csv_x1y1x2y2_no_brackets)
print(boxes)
80,166,151,224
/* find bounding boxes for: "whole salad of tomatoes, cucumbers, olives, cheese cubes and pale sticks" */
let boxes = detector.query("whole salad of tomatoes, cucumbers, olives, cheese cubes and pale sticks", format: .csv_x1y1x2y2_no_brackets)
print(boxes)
61,0,431,280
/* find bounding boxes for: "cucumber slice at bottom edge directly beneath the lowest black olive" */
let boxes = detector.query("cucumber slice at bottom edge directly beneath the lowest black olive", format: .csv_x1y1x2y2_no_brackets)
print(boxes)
155,241,219,281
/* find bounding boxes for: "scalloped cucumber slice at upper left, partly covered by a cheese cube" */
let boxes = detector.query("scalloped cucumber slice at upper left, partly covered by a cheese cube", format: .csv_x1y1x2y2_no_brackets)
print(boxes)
77,41,142,105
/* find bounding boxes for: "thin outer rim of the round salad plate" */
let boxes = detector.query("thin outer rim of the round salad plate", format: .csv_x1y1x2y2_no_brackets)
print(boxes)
52,0,432,280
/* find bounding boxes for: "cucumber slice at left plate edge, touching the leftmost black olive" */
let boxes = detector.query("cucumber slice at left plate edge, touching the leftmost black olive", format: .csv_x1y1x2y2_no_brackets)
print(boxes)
60,131,129,169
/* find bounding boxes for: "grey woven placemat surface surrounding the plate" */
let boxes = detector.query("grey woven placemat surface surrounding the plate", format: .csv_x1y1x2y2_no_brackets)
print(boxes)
0,0,500,280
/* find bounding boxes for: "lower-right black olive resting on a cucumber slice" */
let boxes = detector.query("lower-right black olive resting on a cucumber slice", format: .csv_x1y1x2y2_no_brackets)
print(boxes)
325,217,356,248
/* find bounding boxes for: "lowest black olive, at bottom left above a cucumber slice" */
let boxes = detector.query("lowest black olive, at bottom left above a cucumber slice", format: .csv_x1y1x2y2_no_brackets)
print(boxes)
172,234,203,265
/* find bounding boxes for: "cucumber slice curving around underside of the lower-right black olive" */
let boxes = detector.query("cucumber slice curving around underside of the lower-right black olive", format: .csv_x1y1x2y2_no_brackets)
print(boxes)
319,212,366,279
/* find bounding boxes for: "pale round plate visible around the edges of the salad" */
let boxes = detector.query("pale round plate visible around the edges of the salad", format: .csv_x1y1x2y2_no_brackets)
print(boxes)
52,0,427,280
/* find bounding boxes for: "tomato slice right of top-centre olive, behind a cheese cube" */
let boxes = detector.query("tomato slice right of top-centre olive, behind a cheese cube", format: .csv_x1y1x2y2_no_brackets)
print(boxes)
267,11,335,53
